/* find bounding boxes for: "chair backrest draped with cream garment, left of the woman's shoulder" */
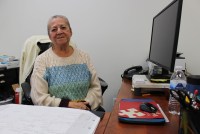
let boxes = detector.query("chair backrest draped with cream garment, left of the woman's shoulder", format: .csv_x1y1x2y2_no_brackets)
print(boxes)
19,35,51,105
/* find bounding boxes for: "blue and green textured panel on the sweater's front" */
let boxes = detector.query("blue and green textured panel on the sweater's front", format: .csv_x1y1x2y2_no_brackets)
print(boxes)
44,64,91,100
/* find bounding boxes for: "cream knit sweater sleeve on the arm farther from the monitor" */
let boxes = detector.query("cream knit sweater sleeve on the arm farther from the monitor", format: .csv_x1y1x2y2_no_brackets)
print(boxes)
31,56,61,106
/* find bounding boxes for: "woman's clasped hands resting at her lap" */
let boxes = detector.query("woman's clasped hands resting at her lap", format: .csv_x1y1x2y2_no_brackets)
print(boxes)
68,101,90,110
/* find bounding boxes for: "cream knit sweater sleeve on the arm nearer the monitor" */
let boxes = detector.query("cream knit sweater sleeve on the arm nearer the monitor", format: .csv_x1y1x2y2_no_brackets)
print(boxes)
85,55,102,110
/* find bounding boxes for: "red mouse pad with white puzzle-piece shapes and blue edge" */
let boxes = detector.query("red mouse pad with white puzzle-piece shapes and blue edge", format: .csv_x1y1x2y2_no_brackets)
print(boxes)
118,99,165,124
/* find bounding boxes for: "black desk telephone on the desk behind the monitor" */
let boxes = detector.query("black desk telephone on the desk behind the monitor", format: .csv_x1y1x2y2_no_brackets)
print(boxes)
121,66,148,80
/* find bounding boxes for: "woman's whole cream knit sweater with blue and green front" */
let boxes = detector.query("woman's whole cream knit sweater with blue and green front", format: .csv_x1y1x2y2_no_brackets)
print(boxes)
31,47,102,109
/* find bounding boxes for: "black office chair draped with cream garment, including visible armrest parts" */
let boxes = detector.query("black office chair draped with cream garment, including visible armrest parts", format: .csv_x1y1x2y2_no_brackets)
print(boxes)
20,36,108,112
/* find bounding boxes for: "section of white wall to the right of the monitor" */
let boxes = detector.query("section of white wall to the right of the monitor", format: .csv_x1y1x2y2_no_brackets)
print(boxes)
179,0,200,75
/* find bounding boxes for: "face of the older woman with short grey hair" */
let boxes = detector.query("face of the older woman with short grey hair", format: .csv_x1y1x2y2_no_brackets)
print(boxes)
49,18,72,46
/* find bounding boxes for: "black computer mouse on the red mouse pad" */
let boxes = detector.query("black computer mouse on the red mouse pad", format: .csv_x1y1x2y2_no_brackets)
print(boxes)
140,102,158,113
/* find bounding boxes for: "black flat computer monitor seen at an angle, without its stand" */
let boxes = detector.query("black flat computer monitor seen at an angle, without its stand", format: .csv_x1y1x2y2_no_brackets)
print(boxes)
148,0,183,72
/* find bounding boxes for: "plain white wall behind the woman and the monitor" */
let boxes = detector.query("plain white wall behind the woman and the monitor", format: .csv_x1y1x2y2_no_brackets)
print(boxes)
0,0,200,111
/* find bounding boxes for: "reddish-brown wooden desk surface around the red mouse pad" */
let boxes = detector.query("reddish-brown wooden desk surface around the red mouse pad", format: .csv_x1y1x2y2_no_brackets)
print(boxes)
105,80,179,134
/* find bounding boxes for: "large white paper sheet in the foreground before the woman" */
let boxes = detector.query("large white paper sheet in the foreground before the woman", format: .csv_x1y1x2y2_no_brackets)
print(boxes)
0,104,100,134
